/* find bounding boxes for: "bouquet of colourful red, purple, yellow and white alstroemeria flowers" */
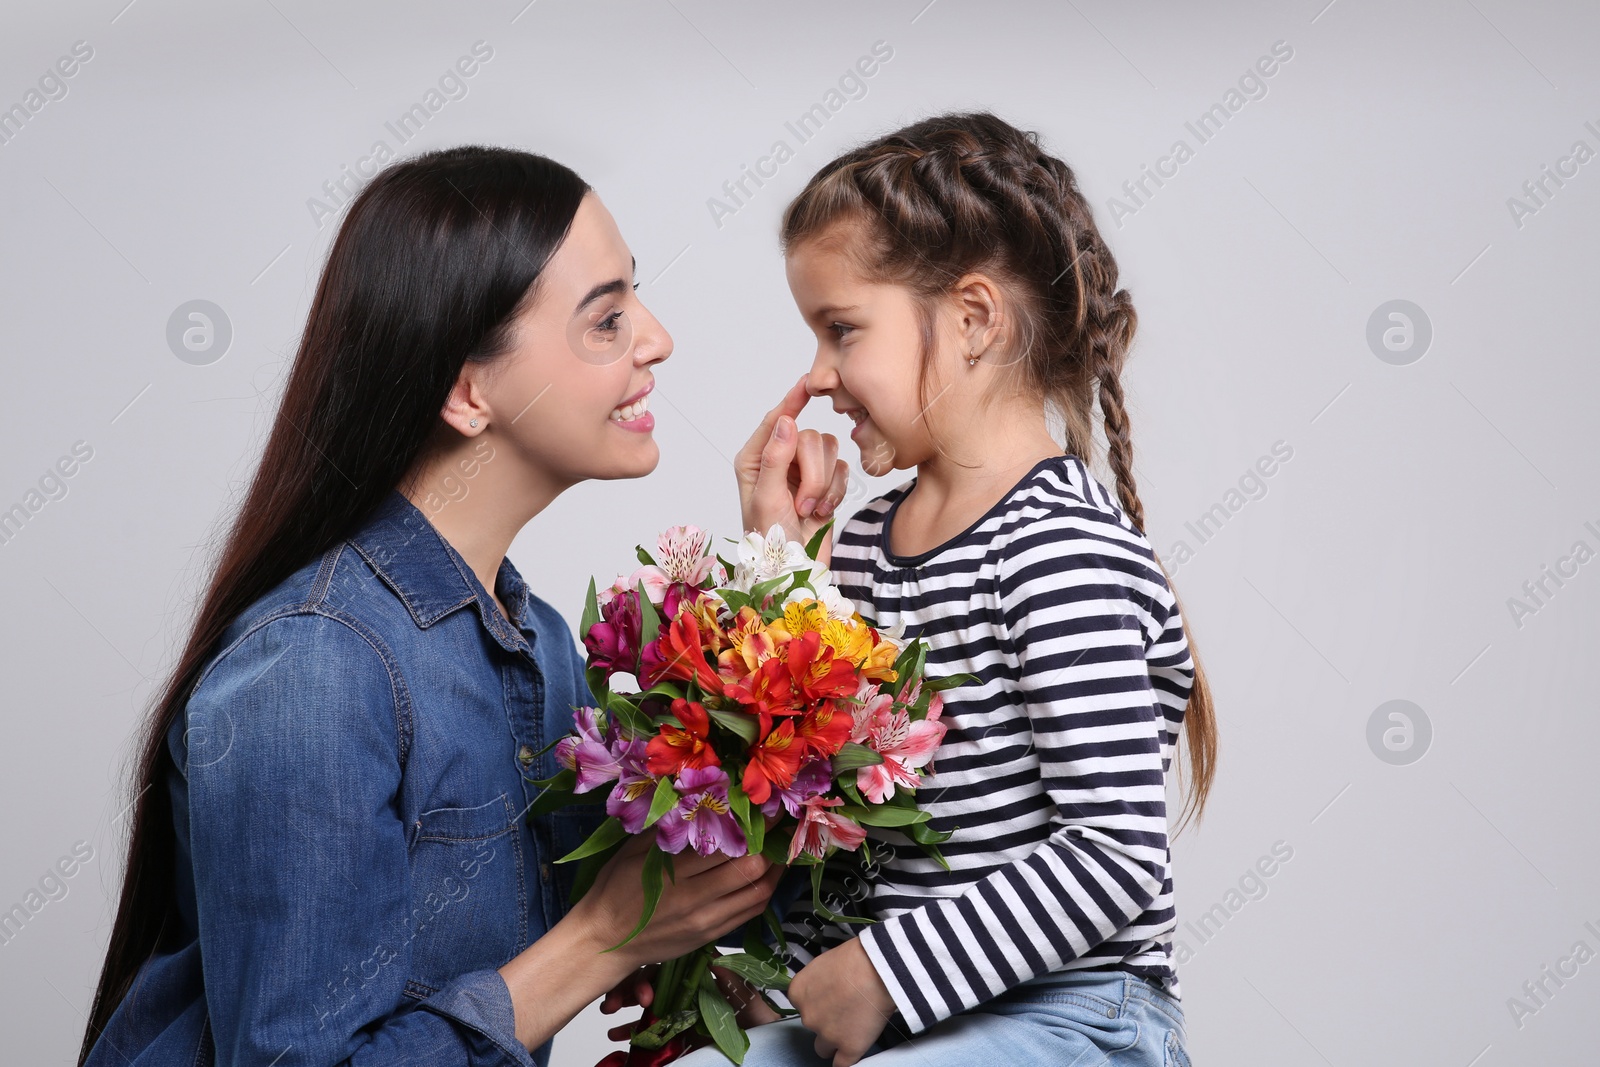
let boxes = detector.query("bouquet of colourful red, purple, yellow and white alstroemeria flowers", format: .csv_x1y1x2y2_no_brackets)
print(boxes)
531,526,971,1064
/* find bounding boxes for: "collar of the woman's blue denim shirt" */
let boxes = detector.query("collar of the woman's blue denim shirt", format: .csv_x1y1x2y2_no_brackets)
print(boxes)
349,490,536,653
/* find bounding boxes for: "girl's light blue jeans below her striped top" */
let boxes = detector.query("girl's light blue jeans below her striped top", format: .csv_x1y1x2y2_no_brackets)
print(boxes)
674,971,1189,1067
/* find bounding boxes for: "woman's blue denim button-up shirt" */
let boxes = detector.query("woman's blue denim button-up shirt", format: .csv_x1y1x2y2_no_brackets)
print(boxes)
88,493,605,1067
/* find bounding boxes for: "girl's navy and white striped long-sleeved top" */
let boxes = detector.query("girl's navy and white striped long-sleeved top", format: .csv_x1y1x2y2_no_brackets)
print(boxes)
784,454,1194,1033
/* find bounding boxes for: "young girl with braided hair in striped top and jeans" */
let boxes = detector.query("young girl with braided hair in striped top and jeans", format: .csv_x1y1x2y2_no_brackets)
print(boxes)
694,114,1216,1067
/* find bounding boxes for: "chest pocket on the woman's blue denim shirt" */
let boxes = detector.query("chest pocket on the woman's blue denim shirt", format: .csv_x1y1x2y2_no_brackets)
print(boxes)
406,793,528,997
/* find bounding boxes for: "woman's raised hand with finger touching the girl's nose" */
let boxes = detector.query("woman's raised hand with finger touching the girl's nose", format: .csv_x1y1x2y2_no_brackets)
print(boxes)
733,376,850,566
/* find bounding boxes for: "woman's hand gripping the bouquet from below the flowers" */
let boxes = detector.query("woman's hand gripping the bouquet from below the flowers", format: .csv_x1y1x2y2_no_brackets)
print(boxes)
568,829,784,992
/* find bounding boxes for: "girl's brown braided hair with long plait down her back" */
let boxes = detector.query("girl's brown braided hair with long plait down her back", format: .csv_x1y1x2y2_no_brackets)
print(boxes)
781,112,1216,821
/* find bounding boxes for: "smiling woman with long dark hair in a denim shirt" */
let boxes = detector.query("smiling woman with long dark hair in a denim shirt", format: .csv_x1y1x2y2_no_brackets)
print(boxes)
80,147,842,1067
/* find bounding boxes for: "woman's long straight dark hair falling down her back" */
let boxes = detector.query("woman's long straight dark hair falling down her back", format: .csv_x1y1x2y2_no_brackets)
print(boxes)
78,146,589,1067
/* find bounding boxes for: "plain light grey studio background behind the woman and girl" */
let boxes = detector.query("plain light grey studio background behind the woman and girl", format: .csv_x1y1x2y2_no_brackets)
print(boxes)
0,0,1600,1067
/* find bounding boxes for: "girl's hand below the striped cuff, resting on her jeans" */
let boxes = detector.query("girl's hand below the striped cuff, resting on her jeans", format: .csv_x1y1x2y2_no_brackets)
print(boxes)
789,937,894,1067
